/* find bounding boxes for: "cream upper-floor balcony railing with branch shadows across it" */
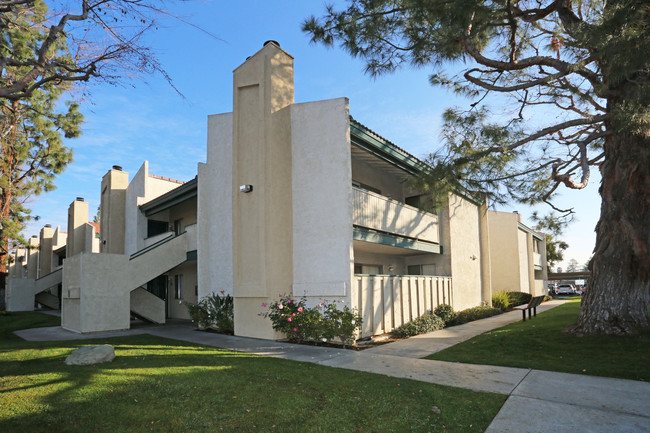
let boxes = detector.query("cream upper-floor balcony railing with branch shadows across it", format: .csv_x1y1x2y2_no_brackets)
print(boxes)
352,187,440,243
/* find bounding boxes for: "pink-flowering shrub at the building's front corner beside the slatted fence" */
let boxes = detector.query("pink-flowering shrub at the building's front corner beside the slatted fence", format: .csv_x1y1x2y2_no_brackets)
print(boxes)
261,294,362,346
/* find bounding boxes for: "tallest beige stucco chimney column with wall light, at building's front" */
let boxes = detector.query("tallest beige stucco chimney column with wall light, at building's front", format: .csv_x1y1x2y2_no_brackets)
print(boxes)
232,42,293,339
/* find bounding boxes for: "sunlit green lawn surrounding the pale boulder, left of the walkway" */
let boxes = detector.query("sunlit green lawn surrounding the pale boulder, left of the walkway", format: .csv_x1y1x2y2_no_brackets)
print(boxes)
0,313,505,433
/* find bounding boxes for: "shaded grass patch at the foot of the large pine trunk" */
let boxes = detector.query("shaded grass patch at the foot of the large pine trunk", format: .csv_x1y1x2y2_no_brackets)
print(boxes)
427,298,650,381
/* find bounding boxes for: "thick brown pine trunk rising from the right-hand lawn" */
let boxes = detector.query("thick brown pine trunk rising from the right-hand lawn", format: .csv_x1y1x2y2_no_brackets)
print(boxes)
572,128,650,335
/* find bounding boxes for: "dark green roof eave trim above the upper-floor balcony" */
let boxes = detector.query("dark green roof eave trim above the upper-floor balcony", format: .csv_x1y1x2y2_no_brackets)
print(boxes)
350,116,483,206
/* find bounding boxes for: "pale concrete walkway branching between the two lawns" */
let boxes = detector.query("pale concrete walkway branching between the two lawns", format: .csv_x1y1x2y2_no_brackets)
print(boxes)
16,301,650,433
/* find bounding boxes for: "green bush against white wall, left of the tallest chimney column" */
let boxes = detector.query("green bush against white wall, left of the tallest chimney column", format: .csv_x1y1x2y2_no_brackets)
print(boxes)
185,290,235,334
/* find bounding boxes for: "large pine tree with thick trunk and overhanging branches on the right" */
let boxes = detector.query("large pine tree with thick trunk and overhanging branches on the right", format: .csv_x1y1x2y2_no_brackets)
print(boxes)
303,0,650,334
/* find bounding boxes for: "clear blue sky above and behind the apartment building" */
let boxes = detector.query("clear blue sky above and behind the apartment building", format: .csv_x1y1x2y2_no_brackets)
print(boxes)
25,0,600,270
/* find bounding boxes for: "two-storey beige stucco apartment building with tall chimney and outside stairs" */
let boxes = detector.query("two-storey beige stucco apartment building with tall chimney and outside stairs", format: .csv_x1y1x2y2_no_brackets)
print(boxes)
9,42,546,339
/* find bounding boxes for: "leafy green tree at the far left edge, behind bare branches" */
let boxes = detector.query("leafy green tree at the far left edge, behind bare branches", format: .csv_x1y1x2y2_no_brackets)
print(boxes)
0,2,83,280
